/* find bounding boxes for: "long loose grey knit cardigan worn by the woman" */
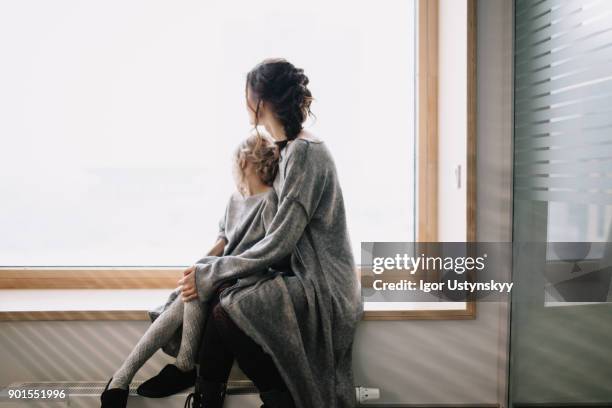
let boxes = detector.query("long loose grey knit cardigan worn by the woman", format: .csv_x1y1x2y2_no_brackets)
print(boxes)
195,138,363,408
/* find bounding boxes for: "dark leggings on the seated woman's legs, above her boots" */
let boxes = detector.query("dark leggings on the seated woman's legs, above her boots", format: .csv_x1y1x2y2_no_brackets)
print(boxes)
199,283,287,392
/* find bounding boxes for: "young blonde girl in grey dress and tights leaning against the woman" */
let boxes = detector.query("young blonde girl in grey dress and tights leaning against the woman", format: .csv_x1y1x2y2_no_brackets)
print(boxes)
100,135,279,408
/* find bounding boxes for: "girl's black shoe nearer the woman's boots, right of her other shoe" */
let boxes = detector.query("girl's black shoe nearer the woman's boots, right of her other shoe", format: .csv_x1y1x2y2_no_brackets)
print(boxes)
136,364,196,398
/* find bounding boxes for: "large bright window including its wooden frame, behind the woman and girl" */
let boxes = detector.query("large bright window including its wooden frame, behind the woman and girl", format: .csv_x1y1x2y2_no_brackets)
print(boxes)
0,0,476,320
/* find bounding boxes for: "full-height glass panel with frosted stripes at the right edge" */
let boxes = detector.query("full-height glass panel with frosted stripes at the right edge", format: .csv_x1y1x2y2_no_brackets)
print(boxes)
510,0,612,407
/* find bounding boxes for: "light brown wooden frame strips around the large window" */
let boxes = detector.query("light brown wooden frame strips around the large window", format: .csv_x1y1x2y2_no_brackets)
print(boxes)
0,0,476,321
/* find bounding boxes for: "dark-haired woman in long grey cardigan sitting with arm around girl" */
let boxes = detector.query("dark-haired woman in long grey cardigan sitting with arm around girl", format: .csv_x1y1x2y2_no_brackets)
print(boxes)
182,59,363,408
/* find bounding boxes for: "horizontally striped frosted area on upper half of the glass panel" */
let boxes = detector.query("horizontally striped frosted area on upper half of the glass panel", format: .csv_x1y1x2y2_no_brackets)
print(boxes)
514,0,612,205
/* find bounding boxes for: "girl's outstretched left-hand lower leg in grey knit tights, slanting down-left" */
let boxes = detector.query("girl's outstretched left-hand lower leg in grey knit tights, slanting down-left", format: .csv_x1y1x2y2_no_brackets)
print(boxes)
108,297,183,389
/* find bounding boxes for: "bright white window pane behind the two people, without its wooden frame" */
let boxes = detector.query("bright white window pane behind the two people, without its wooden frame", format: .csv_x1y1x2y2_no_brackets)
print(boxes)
0,0,415,266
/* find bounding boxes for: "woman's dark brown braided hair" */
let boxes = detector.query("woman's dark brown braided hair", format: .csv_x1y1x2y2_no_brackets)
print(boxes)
246,58,313,148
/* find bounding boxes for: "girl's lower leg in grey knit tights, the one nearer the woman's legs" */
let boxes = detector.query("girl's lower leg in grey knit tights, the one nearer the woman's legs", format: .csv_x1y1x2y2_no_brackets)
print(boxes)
176,299,205,371
